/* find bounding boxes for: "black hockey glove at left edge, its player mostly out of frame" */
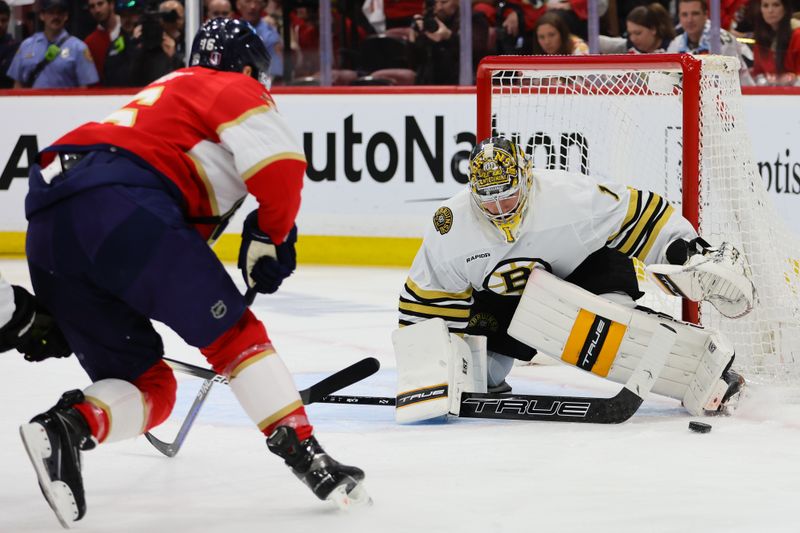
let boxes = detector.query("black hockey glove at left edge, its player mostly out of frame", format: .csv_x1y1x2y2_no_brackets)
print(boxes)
0,285,72,361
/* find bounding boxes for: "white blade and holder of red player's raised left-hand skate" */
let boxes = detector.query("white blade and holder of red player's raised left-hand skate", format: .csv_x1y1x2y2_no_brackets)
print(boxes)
19,424,78,529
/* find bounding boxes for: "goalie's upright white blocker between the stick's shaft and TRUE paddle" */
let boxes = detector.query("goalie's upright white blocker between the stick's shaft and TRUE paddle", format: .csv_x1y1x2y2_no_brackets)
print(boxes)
392,318,487,424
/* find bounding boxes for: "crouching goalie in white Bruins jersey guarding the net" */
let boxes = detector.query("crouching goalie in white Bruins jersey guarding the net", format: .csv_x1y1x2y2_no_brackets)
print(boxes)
393,137,755,422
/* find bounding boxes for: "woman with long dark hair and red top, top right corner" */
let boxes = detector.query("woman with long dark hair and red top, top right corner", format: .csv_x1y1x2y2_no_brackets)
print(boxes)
751,0,800,85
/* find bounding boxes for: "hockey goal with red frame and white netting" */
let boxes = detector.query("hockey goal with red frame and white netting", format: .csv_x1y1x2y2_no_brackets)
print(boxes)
477,54,800,390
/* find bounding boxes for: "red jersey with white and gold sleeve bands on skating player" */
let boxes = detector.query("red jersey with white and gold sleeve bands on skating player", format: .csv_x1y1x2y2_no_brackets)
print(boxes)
42,67,306,244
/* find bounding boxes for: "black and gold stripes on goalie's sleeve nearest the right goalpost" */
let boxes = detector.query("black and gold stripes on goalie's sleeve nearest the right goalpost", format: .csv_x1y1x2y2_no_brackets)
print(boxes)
606,187,675,261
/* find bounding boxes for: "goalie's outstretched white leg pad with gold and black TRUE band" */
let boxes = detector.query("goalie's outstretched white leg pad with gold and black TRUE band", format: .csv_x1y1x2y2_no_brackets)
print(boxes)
509,269,733,415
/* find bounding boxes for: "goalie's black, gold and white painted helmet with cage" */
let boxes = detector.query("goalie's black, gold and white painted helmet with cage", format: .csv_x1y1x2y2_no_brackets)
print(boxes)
469,137,533,242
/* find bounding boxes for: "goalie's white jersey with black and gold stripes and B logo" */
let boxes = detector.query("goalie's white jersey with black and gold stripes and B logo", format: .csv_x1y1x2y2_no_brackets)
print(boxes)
399,170,697,332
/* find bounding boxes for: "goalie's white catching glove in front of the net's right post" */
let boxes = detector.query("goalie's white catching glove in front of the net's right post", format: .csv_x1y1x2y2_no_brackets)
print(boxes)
645,237,755,318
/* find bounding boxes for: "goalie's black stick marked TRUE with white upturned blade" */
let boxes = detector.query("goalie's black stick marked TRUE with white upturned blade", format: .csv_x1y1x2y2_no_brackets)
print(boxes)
320,323,677,424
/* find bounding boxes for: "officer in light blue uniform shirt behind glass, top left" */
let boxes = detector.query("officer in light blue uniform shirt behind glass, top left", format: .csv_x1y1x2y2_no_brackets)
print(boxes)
8,0,98,89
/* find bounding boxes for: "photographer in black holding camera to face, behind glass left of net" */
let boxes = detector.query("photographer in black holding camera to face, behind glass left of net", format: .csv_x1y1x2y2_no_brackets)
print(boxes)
409,0,488,85
